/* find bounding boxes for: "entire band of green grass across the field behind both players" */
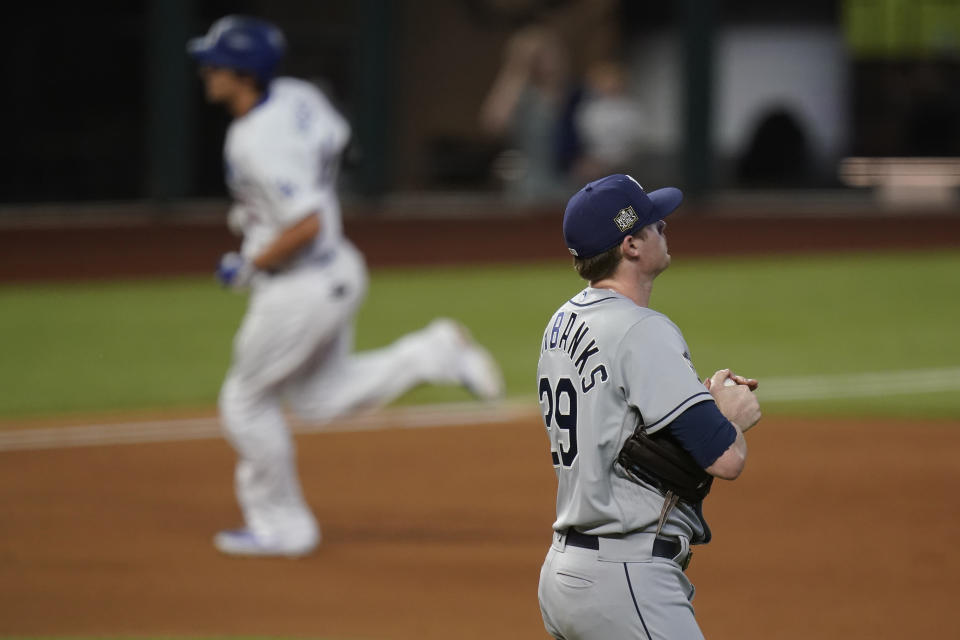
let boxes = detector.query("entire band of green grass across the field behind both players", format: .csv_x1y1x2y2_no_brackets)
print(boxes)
0,252,960,418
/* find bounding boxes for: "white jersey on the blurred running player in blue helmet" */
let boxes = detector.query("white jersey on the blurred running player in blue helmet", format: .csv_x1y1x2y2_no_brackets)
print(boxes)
224,78,350,266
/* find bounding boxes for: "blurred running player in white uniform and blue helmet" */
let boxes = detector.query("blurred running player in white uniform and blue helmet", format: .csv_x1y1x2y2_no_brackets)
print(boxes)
188,16,503,556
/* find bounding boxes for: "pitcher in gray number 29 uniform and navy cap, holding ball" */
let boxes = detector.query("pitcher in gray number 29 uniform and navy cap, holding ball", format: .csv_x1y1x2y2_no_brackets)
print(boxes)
537,174,760,640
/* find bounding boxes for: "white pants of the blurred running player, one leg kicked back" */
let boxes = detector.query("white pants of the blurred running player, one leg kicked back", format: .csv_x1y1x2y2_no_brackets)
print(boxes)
220,245,472,550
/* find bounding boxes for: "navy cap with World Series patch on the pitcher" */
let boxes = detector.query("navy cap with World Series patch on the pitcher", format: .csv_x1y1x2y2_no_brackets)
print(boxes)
563,173,683,258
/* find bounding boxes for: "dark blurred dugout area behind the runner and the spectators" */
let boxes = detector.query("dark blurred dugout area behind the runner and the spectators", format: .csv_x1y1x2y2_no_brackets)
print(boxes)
0,0,960,204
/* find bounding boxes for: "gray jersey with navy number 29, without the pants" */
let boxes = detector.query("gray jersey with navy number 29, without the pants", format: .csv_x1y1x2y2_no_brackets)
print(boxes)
537,287,712,543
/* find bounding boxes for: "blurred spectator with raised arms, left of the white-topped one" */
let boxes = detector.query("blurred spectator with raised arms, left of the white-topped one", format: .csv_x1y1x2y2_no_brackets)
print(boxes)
480,25,578,200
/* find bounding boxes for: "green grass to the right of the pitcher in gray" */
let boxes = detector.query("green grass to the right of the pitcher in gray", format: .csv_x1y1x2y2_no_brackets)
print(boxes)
652,252,960,417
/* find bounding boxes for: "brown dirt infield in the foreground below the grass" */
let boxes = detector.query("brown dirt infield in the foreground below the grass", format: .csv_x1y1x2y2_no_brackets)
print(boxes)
0,417,960,640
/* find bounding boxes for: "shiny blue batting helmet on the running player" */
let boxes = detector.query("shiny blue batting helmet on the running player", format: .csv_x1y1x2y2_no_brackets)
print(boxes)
187,16,287,84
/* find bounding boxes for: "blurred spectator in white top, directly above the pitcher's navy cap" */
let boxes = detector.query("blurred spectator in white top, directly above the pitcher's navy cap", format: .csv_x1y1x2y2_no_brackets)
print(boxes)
573,60,644,182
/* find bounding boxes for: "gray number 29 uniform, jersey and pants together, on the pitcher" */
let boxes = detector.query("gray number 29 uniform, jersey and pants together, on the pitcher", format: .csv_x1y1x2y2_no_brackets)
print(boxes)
537,287,712,640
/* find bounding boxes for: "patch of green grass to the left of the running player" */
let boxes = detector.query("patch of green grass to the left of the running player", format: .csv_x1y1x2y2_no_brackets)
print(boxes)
0,279,245,416
